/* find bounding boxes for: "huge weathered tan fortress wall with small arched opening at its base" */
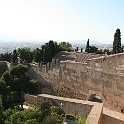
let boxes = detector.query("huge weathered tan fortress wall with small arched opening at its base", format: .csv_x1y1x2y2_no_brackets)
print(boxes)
29,53,124,111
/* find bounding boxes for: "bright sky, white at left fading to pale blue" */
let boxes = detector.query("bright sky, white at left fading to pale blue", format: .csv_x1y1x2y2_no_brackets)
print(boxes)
0,0,124,44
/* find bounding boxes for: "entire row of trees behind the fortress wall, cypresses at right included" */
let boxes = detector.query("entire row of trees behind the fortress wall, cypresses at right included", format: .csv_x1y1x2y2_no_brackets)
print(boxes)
0,29,123,64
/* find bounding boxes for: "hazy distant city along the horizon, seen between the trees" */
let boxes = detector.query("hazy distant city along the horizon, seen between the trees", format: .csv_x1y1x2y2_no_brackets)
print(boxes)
0,40,116,53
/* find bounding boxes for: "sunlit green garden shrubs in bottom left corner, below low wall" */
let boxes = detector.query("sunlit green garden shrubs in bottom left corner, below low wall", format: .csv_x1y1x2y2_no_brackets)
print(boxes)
0,103,63,124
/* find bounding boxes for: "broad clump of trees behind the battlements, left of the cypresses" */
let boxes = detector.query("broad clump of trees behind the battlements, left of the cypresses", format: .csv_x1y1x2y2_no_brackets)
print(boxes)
0,40,73,64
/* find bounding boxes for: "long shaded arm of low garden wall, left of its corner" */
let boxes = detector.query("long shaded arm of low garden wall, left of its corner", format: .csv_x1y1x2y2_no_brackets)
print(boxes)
25,94,93,118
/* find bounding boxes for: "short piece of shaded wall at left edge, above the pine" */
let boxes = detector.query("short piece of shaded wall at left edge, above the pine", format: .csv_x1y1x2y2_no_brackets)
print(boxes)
0,61,10,77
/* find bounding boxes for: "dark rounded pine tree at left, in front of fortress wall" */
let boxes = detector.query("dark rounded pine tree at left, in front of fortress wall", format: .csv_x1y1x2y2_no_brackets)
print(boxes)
0,64,37,109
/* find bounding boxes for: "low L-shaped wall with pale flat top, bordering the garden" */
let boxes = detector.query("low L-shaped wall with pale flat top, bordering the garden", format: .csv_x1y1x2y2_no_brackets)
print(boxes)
25,94,103,124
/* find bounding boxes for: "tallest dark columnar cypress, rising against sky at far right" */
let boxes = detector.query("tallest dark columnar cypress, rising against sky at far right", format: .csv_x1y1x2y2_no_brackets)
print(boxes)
113,28,122,54
